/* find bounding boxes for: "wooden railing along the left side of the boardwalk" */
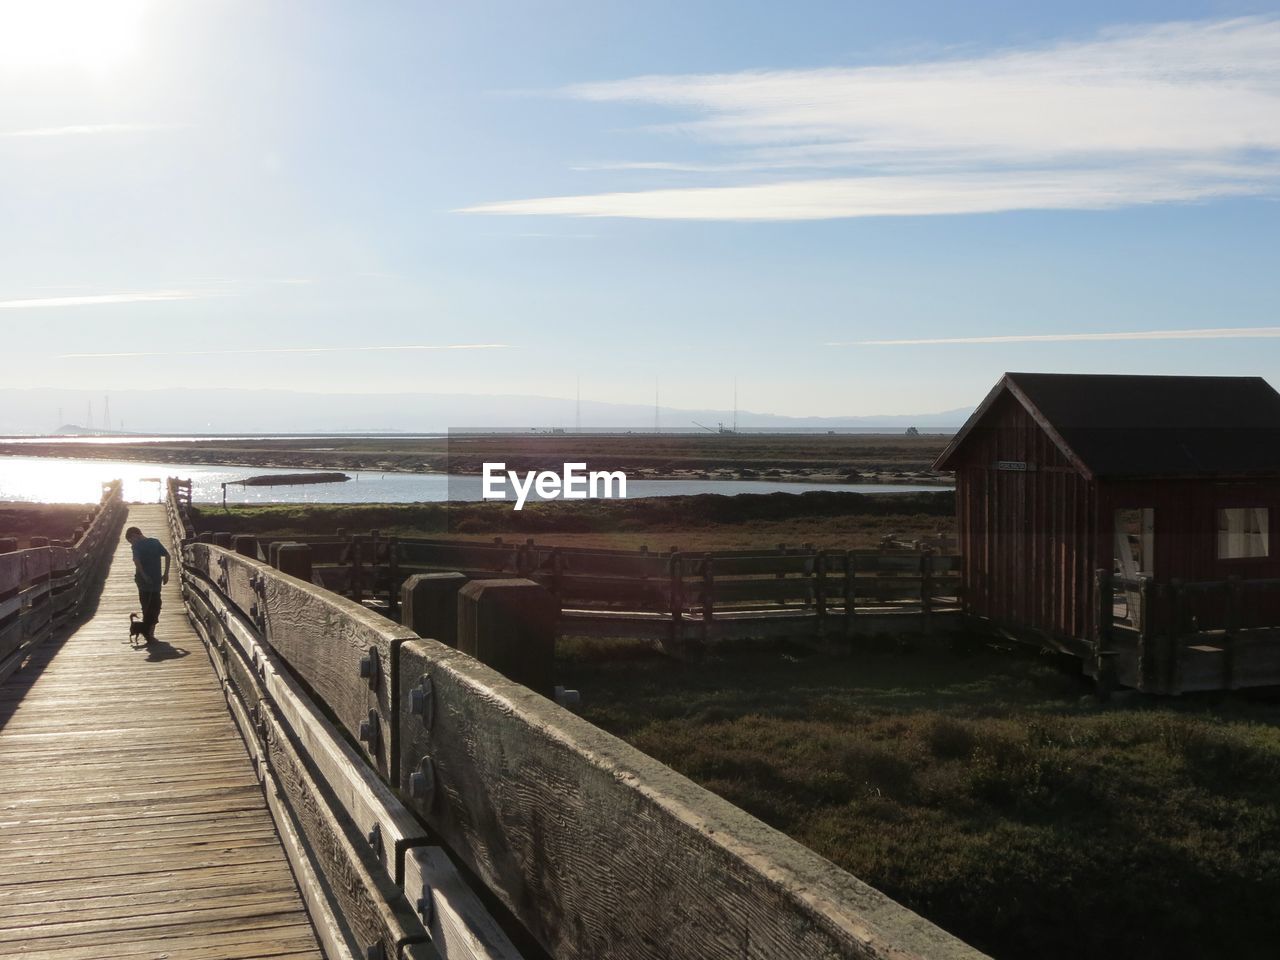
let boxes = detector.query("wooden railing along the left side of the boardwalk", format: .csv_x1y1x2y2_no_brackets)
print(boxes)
0,480,127,680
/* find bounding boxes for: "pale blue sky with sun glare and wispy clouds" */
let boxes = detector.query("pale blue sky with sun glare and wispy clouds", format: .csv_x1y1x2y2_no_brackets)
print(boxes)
0,0,1280,416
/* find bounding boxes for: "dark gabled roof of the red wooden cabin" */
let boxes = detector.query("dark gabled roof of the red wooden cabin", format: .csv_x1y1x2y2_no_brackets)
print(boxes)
936,374,1280,477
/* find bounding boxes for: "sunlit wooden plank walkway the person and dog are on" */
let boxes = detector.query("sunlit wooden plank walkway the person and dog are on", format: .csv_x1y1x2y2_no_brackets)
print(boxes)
0,506,323,960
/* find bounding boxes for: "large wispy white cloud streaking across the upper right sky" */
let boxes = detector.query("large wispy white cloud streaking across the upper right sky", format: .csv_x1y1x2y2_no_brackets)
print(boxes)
466,17,1280,220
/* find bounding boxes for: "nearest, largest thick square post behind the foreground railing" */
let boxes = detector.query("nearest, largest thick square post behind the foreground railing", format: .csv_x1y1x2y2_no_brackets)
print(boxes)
458,580,559,698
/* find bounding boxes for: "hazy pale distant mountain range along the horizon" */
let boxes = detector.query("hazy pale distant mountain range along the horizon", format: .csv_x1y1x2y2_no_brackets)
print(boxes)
0,388,972,435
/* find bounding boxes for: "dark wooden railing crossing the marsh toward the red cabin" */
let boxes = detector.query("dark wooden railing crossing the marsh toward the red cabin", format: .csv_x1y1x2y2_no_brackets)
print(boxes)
185,530,960,645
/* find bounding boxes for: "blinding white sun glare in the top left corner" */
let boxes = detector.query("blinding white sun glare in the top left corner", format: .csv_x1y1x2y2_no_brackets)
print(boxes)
0,0,145,70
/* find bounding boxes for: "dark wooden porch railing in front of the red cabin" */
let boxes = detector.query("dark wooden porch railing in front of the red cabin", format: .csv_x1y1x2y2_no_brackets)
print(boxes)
1094,570,1280,694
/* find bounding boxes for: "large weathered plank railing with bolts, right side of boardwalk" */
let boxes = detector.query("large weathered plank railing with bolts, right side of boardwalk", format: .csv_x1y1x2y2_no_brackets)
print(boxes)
169,488,979,960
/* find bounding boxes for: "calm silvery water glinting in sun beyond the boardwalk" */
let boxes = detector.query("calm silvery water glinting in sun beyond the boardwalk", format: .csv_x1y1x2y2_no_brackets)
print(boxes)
0,457,943,503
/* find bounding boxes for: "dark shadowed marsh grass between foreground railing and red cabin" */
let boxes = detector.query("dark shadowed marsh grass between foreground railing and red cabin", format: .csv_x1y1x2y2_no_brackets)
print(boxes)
558,640,1280,960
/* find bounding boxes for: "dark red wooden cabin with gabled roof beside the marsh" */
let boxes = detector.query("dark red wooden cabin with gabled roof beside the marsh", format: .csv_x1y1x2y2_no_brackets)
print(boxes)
934,374,1280,684
